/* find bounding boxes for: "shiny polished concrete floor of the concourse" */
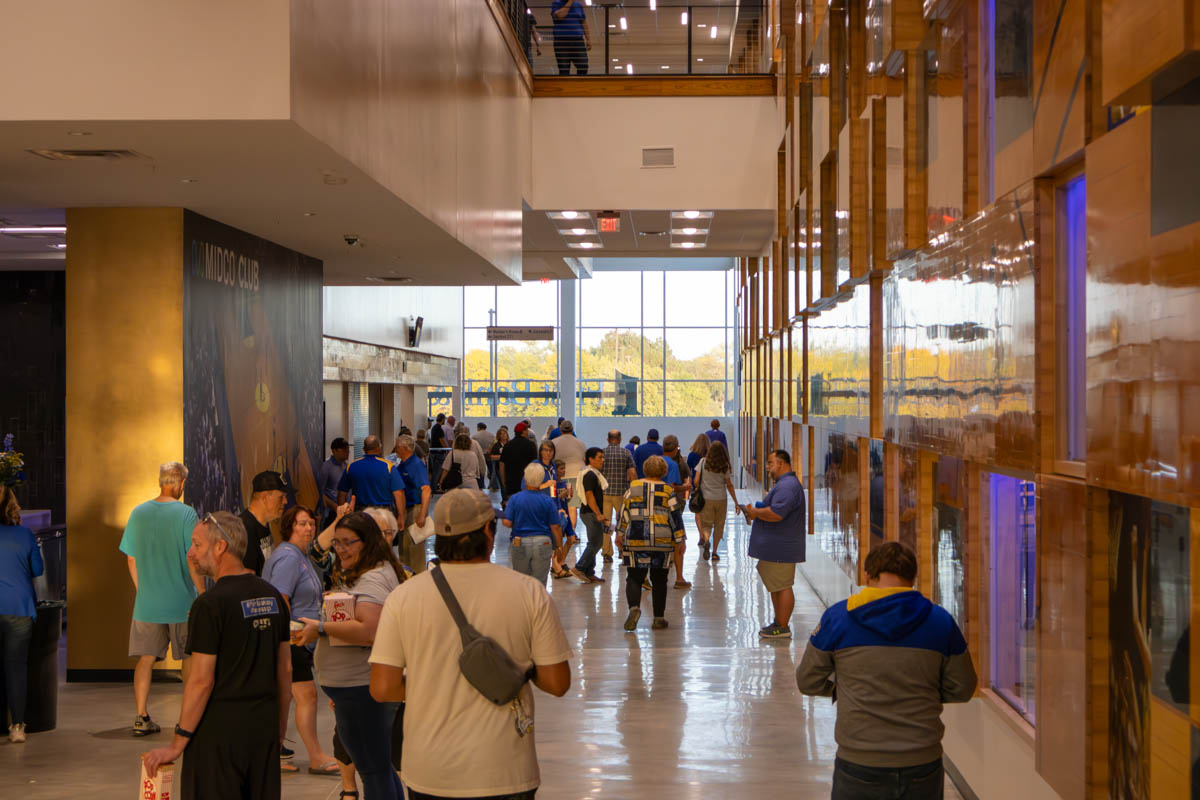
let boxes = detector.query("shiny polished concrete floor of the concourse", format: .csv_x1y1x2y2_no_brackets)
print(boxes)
0,491,959,800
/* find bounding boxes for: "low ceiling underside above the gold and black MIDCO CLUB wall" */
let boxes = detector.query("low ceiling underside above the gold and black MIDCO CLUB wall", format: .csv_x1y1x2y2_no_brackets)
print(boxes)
0,121,509,285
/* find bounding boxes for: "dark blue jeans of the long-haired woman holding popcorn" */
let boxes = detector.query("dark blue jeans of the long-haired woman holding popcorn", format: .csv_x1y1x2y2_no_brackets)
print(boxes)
320,686,404,800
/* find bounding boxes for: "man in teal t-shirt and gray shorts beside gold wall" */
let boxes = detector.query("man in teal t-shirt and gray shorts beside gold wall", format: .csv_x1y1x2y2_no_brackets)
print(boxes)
121,461,204,736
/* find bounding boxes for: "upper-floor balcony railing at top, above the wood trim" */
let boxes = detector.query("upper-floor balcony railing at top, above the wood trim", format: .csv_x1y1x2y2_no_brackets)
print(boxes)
503,0,772,77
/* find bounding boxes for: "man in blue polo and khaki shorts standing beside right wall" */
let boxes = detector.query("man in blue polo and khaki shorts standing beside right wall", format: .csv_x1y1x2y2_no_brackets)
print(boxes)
742,450,808,639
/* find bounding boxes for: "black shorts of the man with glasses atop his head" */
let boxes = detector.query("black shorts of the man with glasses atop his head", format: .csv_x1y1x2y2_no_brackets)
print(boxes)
179,732,281,800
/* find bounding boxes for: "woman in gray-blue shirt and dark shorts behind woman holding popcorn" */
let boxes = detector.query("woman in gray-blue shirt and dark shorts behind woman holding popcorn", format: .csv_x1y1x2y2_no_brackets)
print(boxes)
263,506,337,775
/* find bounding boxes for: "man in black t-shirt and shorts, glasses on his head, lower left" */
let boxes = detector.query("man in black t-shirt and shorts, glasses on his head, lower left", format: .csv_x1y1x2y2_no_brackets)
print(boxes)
145,511,292,800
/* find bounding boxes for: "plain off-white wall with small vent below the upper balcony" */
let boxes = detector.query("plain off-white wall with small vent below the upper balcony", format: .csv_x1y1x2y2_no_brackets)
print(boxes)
530,97,781,209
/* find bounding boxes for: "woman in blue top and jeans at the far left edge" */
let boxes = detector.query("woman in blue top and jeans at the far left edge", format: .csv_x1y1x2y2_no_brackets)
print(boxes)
0,486,42,745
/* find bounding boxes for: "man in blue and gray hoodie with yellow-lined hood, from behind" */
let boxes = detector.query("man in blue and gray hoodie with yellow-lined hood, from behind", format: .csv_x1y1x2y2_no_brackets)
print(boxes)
796,542,977,800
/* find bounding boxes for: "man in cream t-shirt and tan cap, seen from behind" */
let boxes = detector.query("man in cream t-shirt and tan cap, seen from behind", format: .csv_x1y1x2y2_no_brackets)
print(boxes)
371,488,571,800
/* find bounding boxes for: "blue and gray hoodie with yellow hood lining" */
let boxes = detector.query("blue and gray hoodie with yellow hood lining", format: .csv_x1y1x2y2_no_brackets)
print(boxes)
796,588,977,768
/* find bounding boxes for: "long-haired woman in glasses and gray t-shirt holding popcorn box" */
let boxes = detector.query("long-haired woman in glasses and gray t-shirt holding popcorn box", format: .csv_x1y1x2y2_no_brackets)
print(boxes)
294,512,404,800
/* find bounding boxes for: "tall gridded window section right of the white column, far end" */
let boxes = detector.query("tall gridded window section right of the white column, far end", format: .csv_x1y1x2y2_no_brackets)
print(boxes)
576,270,736,416
